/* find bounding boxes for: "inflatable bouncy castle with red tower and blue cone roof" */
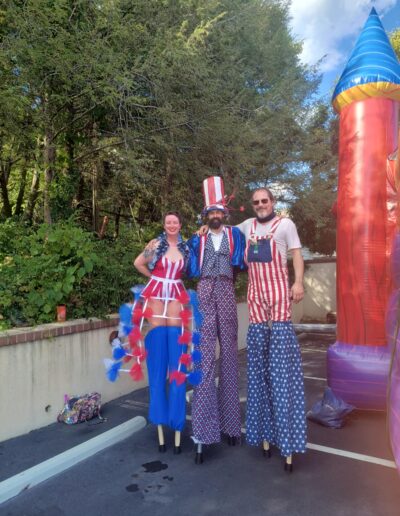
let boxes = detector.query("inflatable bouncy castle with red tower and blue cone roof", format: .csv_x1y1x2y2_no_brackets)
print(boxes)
328,9,400,476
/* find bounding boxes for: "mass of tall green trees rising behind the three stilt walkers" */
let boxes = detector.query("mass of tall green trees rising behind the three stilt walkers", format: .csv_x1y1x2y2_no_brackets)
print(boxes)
0,0,338,326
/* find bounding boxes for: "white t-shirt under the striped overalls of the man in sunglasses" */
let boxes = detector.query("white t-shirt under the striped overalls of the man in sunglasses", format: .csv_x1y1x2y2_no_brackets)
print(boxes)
236,217,301,265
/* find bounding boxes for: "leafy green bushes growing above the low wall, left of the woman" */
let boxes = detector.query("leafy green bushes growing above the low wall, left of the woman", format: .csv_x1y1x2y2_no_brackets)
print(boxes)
0,221,155,328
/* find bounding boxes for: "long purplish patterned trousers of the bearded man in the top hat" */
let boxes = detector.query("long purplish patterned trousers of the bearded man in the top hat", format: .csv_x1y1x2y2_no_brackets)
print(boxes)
192,278,241,444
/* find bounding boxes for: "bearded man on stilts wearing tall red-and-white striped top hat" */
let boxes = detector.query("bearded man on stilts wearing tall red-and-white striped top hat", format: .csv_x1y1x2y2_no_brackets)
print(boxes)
187,177,245,464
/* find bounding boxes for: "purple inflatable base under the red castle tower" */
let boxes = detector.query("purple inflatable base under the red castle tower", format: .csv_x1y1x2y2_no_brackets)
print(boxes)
328,341,390,410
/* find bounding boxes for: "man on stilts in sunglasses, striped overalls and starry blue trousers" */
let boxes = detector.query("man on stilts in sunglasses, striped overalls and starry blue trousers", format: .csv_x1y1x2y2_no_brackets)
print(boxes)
237,188,306,472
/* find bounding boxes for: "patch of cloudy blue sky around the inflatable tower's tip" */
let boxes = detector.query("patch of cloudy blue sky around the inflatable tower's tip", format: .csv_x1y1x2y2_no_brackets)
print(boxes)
290,0,400,100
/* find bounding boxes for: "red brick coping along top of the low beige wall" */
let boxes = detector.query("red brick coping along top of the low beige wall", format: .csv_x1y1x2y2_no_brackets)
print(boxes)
0,314,119,347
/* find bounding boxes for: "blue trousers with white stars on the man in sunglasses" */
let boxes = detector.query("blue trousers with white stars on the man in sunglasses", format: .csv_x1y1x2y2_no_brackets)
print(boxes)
246,322,306,456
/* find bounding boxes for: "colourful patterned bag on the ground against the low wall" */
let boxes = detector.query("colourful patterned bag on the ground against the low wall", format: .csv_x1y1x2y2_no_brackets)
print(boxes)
57,392,103,425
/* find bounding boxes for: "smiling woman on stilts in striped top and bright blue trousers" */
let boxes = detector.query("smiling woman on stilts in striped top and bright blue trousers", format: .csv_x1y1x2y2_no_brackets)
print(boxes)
134,212,191,453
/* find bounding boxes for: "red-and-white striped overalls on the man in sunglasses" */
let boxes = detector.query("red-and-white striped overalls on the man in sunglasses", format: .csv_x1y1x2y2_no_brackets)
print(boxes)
246,218,291,323
